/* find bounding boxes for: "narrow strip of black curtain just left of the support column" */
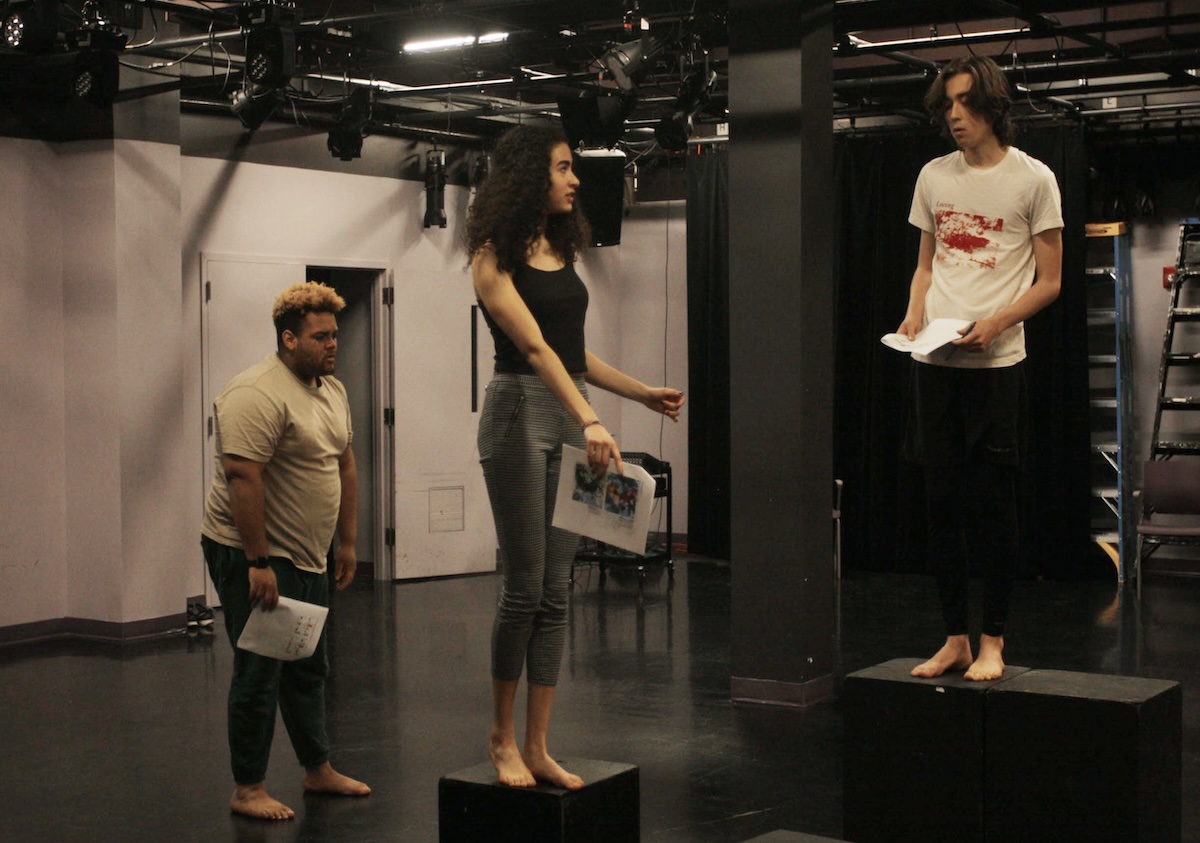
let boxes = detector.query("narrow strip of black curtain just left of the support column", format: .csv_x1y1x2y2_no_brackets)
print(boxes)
685,150,730,560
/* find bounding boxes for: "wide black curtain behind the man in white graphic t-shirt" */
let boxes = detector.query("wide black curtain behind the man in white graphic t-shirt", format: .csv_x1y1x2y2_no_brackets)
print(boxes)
835,126,1112,579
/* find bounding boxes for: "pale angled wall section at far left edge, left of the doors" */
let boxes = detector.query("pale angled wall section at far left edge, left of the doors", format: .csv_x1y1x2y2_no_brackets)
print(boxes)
0,141,191,626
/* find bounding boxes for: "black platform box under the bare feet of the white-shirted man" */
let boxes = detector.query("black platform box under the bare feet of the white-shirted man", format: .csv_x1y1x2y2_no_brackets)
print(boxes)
842,658,1028,843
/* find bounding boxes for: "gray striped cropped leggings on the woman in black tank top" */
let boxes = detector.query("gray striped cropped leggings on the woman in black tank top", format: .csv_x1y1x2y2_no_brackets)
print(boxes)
479,375,587,684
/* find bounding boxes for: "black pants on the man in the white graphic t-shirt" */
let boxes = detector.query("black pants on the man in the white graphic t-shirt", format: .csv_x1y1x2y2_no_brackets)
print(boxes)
905,363,1026,636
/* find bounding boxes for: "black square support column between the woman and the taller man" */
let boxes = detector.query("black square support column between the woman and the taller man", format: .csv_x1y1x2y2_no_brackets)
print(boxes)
730,0,834,705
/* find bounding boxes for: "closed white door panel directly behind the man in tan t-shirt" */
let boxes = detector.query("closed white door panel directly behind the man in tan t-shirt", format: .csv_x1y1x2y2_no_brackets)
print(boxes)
200,256,305,605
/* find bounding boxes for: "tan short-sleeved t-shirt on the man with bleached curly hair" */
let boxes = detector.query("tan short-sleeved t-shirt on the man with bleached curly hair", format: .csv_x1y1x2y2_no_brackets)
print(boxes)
200,354,354,573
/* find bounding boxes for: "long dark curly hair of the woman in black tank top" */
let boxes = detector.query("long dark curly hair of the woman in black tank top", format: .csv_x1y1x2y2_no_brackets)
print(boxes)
467,125,590,273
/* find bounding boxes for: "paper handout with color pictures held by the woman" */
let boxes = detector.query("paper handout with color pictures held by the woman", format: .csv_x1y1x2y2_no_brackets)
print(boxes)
553,444,656,555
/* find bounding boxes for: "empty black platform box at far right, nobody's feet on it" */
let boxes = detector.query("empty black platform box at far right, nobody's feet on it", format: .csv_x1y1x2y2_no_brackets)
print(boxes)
985,670,1183,843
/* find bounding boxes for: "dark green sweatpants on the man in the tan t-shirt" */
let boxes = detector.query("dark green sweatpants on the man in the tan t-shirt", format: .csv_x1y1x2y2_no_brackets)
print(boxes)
200,536,329,784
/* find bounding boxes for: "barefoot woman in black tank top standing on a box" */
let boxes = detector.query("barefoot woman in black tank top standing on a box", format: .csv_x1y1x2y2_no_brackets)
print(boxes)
467,126,684,790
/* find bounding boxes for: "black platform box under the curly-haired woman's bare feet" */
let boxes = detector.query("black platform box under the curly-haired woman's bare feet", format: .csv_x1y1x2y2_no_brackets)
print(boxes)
438,759,641,843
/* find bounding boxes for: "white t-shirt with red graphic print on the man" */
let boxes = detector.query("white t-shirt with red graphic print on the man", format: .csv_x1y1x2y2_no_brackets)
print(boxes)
908,147,1063,369
